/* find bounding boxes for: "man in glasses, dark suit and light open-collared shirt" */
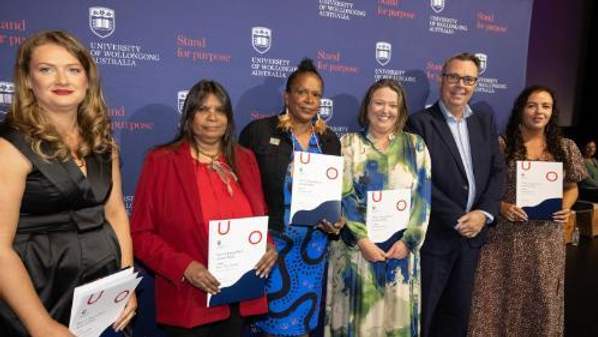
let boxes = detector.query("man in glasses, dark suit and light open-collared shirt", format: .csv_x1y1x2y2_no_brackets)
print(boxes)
407,53,504,337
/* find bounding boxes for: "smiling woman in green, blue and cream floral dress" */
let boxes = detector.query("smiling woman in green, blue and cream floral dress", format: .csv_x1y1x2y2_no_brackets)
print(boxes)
325,80,431,337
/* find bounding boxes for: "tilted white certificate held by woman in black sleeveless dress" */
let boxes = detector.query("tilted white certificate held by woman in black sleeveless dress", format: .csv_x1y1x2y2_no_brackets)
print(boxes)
69,268,141,337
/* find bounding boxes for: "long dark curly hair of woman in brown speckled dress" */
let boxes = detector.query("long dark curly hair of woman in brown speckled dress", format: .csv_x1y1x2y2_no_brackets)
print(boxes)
504,85,566,162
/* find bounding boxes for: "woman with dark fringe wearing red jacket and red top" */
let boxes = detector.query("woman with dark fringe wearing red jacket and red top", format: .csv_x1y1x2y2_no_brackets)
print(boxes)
131,80,277,337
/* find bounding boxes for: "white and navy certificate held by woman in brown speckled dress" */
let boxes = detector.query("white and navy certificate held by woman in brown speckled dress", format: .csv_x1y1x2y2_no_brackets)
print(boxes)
516,161,563,220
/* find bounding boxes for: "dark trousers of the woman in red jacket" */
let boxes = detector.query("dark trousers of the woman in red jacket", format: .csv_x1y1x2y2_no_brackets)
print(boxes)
161,304,244,337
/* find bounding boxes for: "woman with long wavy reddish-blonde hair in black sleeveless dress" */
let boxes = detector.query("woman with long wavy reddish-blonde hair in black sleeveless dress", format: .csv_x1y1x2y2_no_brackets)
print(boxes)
0,32,137,337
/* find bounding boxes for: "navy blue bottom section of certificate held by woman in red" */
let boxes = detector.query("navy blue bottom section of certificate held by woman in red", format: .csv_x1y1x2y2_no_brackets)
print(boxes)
209,269,266,307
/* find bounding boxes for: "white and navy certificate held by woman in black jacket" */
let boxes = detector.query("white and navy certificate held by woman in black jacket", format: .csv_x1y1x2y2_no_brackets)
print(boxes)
290,151,343,226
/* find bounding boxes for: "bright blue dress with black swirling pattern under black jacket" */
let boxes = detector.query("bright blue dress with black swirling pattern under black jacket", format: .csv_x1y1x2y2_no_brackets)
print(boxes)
253,134,328,336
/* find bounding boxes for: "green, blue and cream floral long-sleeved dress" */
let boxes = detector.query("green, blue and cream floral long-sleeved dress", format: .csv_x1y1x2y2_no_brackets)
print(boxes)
325,132,431,337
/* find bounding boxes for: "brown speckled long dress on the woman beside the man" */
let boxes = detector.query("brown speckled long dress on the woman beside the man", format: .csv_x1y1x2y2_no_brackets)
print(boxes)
468,139,587,337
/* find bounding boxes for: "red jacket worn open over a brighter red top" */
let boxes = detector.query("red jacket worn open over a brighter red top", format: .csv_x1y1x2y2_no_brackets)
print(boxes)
131,143,268,328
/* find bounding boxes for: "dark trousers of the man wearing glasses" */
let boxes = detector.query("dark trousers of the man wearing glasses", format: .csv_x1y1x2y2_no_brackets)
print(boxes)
421,241,480,337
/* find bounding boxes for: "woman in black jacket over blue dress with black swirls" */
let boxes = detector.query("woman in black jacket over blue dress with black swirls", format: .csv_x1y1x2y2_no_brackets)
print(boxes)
239,59,342,336
